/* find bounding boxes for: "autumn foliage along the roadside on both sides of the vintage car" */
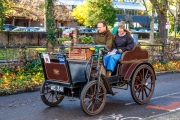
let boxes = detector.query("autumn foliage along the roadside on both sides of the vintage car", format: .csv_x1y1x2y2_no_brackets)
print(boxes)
0,60,180,95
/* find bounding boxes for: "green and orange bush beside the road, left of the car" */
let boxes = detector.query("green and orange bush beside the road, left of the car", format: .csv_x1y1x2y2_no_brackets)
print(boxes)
0,59,44,95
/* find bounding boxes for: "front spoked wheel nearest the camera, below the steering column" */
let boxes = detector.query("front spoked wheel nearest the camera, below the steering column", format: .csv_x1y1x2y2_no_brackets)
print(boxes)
80,80,106,115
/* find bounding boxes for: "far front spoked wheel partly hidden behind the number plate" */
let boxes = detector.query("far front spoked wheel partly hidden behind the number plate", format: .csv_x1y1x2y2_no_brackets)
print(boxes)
40,81,64,107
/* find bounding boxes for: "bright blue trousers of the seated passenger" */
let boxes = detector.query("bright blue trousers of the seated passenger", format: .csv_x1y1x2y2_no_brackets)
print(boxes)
103,53,123,72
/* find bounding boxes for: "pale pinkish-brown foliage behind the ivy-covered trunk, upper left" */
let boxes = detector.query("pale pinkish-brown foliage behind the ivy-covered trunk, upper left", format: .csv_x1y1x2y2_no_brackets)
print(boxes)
10,0,74,22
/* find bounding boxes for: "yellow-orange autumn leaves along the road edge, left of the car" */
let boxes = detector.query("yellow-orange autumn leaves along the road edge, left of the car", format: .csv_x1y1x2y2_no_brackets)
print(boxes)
0,66,44,95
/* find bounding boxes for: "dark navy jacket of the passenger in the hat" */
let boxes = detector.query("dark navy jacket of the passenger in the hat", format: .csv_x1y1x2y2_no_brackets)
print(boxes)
112,34,135,52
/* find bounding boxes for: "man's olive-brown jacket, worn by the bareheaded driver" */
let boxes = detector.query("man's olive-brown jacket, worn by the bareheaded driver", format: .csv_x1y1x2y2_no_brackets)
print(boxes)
94,30,114,50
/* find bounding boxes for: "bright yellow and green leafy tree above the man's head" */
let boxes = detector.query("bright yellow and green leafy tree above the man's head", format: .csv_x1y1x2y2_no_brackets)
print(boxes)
72,0,116,27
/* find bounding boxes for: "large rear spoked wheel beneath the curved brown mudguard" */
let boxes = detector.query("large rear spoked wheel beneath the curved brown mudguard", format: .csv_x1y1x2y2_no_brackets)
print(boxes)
131,64,155,104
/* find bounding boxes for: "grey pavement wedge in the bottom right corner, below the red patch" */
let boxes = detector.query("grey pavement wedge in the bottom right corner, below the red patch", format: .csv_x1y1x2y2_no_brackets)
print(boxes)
143,109,180,120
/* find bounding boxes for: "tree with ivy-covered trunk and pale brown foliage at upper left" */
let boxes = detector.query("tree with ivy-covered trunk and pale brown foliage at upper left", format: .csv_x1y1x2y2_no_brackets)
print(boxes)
0,0,74,51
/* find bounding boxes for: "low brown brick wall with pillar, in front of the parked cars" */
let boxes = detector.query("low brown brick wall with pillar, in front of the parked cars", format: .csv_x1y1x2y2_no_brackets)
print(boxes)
0,29,152,46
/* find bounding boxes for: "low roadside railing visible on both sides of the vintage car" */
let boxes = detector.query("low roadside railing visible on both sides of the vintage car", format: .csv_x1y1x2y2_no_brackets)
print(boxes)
0,42,180,62
